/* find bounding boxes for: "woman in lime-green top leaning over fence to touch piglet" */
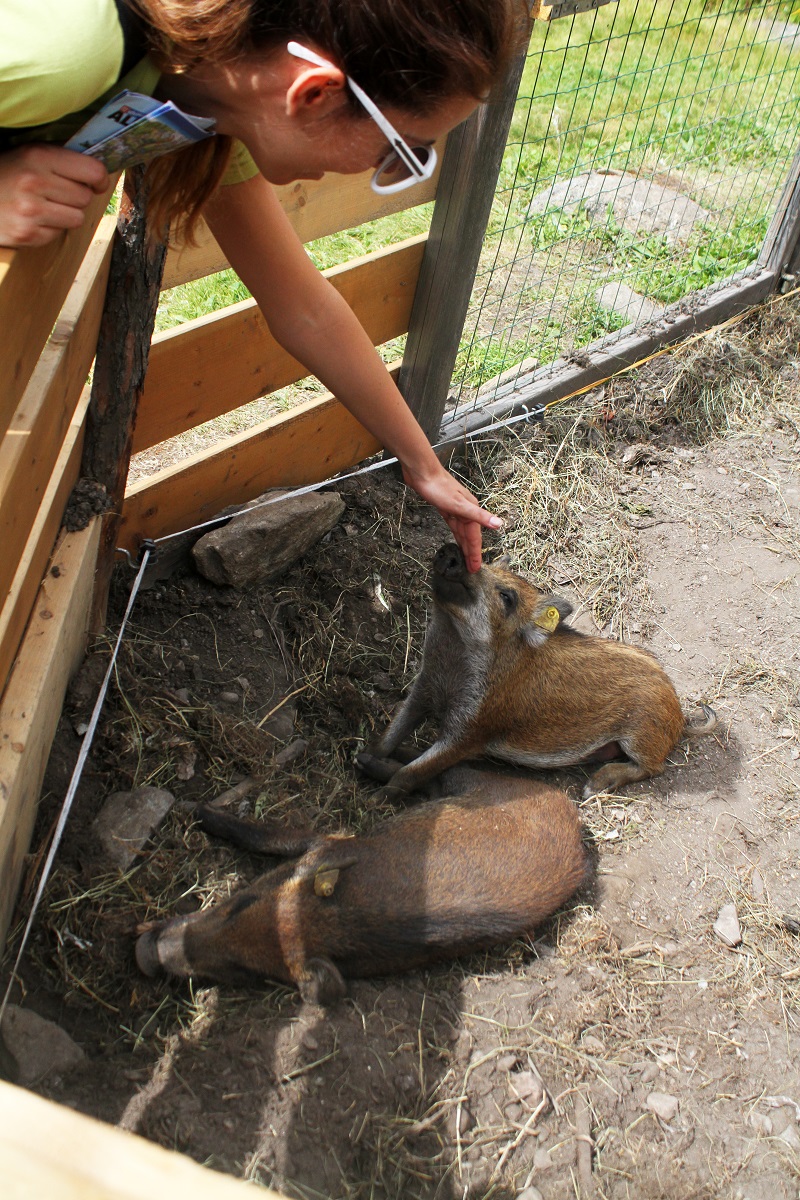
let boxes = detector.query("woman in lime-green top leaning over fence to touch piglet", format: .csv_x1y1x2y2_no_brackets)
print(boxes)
0,0,527,571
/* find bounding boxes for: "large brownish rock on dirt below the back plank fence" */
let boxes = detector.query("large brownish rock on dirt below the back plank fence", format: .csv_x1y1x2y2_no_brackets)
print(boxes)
192,492,344,588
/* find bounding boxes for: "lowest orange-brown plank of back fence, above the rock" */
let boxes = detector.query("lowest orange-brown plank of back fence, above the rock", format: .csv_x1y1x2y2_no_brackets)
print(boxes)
119,362,399,550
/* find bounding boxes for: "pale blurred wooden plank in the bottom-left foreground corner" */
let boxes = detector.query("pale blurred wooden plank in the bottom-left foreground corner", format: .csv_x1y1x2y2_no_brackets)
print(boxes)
0,1082,281,1200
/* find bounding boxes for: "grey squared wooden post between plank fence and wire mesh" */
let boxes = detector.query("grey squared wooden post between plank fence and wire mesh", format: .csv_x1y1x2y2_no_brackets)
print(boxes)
399,37,528,442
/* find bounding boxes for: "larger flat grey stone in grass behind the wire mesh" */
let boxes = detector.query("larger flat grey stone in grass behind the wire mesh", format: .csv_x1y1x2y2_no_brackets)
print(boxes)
528,170,711,244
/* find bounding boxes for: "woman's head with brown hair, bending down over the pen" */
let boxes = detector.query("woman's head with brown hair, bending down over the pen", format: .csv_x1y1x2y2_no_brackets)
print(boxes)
127,0,528,238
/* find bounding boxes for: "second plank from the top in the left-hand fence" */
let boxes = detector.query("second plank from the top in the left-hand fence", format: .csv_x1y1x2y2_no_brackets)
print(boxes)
0,216,116,609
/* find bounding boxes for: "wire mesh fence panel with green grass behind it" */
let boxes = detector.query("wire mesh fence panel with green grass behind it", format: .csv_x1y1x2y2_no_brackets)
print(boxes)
449,0,800,416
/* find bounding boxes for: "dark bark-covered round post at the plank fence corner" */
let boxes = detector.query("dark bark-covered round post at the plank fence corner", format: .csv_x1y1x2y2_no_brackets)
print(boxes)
80,167,167,632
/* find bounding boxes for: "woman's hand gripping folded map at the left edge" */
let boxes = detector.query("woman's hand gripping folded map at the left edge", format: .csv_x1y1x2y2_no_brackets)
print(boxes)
0,144,109,248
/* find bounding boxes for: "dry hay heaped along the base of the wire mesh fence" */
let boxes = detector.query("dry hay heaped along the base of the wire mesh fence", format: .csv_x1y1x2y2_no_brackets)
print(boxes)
453,286,800,636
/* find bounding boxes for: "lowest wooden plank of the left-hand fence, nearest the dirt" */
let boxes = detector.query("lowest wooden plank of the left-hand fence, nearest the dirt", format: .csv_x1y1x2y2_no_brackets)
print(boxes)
0,517,101,944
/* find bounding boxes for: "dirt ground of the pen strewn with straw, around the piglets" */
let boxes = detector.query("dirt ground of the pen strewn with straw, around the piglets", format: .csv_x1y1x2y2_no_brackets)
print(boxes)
6,296,800,1200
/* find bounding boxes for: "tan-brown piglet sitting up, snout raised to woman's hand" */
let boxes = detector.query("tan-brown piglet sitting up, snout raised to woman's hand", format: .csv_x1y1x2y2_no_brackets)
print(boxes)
372,544,716,799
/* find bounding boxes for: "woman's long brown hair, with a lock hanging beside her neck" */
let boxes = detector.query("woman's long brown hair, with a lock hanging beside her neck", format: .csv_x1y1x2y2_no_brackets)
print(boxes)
127,0,528,240
